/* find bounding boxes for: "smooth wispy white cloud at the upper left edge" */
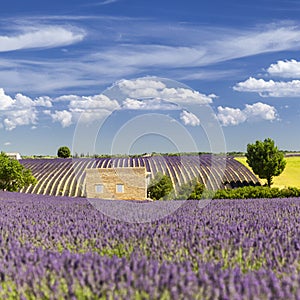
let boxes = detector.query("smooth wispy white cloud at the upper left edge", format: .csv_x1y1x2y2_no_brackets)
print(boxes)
0,26,85,52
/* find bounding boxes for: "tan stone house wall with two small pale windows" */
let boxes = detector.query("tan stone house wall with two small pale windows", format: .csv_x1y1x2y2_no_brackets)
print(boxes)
86,167,147,200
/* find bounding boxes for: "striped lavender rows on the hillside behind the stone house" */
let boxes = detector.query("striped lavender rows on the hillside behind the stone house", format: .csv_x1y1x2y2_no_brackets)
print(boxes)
21,155,258,197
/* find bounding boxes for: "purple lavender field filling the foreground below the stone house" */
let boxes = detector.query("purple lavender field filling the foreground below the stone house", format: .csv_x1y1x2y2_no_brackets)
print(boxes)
0,192,300,299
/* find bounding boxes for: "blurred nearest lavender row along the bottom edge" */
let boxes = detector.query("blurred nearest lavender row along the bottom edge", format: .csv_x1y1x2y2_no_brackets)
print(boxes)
0,241,300,299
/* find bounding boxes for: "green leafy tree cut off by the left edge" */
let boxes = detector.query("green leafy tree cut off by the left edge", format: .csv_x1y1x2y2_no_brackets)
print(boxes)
0,152,37,192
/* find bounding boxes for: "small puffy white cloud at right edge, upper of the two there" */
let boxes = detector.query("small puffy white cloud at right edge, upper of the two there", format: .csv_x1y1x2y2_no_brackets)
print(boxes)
267,59,300,78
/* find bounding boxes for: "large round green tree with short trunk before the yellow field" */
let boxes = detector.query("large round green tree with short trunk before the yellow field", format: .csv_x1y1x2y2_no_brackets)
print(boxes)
246,138,286,187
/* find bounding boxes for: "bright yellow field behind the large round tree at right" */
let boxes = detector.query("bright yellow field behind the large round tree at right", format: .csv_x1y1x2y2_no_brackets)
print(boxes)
235,156,300,188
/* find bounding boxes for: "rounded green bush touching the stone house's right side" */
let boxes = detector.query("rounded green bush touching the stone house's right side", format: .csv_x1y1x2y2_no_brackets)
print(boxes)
147,172,173,200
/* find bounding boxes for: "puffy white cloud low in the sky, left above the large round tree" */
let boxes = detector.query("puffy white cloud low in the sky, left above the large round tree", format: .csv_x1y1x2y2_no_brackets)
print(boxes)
217,102,277,126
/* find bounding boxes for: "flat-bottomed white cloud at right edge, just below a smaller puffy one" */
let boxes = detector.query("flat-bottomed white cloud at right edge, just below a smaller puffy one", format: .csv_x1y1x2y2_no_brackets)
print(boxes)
233,77,300,97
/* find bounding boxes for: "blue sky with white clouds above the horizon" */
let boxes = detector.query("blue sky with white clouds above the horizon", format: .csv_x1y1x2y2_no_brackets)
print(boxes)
0,0,300,155
